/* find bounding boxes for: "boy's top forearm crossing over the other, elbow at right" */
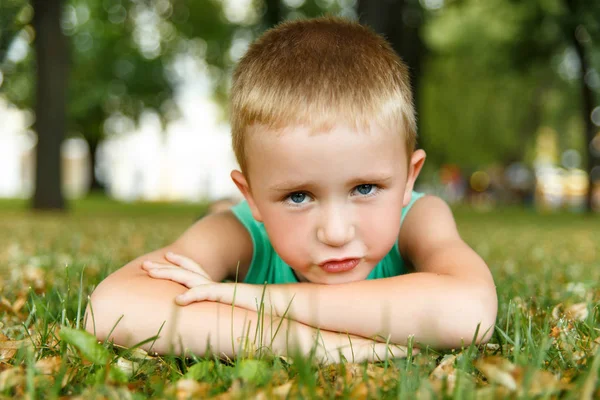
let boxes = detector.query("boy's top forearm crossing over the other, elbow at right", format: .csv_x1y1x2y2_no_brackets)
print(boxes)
226,273,497,348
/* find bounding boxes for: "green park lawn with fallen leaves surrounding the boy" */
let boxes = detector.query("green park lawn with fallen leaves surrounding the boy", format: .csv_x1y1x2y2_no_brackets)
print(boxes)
0,197,600,399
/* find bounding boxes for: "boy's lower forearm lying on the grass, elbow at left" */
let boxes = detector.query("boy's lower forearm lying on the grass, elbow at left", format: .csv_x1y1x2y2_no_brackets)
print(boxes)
86,277,406,362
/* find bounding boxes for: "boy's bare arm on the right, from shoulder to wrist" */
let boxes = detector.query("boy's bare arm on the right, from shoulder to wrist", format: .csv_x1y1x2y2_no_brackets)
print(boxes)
178,196,497,348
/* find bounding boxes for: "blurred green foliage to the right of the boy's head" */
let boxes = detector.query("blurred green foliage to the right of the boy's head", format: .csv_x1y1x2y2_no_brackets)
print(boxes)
420,0,600,174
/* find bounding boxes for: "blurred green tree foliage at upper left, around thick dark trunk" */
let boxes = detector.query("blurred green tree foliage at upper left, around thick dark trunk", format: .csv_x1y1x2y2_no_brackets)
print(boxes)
0,0,234,197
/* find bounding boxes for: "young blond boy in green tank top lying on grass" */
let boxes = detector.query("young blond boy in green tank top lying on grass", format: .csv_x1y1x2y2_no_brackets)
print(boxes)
86,18,497,361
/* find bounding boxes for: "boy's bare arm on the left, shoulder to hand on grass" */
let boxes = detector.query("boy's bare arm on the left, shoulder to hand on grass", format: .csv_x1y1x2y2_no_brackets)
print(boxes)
85,211,406,362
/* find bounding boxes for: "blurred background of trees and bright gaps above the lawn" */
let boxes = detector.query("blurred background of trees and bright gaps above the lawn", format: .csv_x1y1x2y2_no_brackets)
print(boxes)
0,0,600,213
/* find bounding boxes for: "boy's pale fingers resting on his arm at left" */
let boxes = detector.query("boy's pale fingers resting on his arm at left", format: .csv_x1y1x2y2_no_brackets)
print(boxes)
142,252,215,288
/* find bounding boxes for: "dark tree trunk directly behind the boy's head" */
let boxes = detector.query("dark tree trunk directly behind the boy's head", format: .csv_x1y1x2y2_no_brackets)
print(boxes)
357,0,425,147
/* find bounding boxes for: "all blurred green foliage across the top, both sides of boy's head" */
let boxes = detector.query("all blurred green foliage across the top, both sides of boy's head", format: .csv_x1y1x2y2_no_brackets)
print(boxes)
0,0,600,178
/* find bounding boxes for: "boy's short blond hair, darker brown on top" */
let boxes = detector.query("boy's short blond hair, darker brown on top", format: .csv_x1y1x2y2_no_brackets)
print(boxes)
230,17,416,173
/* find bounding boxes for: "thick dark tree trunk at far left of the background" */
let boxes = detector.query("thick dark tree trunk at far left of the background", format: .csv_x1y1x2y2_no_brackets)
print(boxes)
32,0,68,210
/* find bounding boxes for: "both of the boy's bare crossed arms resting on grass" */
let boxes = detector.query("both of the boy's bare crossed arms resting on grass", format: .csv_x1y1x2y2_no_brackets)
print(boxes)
86,196,497,361
